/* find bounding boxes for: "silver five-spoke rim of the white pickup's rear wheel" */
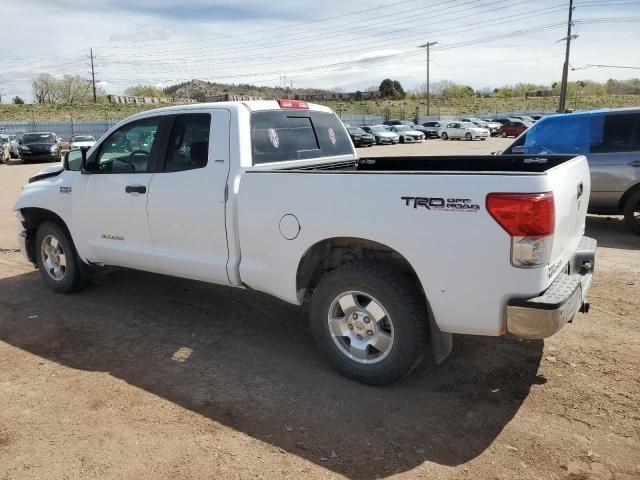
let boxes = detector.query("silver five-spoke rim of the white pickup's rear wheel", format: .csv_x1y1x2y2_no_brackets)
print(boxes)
327,290,395,364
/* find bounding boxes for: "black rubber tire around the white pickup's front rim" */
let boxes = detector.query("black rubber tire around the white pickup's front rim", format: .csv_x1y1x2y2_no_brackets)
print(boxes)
34,221,90,293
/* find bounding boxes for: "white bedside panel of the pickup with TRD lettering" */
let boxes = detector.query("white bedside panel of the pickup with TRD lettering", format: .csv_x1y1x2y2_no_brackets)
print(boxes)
237,170,551,335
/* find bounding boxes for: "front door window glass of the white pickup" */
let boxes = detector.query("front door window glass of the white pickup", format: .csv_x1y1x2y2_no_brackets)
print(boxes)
97,117,160,173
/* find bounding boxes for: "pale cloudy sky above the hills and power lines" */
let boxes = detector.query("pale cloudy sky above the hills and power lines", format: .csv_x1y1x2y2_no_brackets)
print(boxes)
0,0,640,103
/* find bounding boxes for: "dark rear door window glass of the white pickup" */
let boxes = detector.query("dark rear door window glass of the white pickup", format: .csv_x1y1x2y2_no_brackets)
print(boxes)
164,113,211,172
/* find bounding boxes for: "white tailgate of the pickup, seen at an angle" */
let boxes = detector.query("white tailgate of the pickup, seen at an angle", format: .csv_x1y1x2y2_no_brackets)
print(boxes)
547,156,591,283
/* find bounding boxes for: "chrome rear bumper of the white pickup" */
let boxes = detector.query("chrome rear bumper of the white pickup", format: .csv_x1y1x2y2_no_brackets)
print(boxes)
507,237,597,339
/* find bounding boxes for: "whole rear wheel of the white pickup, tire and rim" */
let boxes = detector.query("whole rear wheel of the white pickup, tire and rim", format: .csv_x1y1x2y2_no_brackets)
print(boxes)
311,263,427,385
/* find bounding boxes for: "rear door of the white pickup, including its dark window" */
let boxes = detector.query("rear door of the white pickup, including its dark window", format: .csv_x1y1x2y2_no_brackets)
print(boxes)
148,109,231,284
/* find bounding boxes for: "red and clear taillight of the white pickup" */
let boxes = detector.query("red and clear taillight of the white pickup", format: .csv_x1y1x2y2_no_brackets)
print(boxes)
487,192,555,268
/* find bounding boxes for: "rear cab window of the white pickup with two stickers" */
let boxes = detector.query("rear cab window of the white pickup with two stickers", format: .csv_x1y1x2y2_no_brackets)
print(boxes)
251,110,354,165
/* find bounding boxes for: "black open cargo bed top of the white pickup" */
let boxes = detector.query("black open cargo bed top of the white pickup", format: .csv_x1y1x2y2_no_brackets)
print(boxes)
278,155,575,174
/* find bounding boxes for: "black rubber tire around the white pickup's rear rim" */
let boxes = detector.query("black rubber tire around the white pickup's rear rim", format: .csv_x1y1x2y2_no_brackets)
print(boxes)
311,263,427,385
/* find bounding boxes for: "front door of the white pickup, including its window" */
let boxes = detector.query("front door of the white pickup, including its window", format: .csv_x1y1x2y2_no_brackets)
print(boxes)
71,117,162,271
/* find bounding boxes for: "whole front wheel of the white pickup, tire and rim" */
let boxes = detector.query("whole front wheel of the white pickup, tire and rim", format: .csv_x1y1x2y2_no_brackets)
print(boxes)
35,222,88,293
